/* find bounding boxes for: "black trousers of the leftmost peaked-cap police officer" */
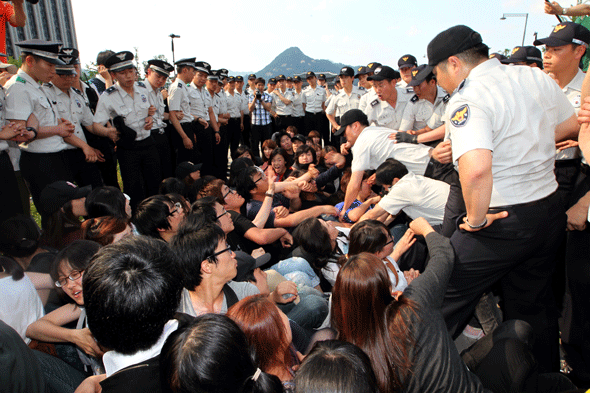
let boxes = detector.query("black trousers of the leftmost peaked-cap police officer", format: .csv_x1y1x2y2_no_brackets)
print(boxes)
19,150,74,219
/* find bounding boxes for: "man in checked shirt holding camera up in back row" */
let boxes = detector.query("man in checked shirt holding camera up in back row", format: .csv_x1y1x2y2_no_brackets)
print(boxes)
248,78,272,157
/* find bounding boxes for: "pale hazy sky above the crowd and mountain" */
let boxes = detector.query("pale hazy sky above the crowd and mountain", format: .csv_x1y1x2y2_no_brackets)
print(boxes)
72,0,575,72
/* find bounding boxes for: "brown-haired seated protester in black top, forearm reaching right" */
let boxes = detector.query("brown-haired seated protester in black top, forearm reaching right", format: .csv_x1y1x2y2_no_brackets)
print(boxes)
200,179,293,254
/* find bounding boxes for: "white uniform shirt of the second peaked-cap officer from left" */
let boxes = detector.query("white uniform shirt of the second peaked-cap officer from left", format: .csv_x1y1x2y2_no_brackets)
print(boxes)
42,83,93,149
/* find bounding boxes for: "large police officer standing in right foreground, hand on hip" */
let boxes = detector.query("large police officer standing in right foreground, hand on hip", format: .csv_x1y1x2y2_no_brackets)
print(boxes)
427,26,578,372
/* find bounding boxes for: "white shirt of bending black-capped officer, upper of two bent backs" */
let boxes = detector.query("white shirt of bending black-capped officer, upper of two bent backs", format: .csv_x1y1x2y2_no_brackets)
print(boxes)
351,126,432,175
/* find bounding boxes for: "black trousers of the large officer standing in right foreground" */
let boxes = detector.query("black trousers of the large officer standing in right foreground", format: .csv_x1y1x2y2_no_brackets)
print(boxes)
442,193,566,372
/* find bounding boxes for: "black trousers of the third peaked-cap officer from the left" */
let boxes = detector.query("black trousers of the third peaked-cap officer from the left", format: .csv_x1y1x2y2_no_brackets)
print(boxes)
117,137,162,211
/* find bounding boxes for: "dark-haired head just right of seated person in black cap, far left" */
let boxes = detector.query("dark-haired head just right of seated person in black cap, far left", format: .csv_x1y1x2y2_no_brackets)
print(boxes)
84,186,131,219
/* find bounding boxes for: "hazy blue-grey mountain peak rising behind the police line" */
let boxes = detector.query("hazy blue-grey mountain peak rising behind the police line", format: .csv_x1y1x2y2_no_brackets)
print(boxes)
255,46,352,79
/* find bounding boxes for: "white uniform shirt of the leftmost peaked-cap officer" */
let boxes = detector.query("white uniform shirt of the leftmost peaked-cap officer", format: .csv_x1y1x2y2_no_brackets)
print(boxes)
4,69,68,153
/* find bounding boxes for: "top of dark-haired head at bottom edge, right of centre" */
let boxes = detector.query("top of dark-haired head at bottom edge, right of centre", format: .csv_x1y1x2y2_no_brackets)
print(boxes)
294,340,379,393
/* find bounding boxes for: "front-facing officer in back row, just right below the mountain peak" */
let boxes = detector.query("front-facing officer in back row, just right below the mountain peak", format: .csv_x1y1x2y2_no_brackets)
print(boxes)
306,71,330,145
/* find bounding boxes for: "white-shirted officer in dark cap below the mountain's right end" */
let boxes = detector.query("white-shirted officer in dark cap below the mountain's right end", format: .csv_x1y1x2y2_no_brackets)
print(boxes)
326,67,367,147
